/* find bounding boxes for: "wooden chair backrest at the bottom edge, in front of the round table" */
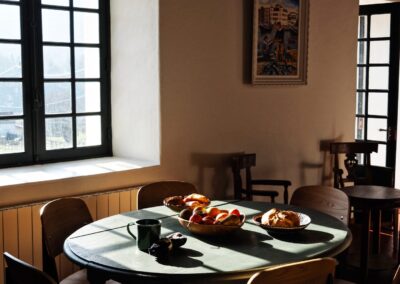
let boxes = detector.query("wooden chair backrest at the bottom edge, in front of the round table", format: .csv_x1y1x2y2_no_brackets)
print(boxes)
247,257,336,284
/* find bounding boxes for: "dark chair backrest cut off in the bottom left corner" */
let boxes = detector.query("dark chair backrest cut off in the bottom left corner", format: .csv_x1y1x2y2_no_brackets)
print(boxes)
3,252,56,284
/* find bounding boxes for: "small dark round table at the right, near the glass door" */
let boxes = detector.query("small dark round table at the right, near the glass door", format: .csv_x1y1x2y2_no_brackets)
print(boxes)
341,185,400,283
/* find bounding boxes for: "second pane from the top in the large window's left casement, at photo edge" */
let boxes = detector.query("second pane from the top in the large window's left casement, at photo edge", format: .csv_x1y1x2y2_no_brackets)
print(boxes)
0,43,21,78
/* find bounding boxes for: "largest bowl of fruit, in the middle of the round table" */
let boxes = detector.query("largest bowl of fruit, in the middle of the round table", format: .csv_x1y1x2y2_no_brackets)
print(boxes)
178,206,246,236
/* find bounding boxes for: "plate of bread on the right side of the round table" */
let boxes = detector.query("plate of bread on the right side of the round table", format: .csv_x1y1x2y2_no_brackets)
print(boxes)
253,208,311,233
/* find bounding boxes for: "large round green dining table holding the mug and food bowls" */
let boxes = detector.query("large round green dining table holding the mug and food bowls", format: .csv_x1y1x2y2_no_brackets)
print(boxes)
64,200,352,283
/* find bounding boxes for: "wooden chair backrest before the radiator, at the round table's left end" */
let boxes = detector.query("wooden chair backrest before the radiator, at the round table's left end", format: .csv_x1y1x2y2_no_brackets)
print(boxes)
40,198,93,281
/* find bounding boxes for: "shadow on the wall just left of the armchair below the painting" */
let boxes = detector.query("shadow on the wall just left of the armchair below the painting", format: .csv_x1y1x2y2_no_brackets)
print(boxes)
191,152,243,199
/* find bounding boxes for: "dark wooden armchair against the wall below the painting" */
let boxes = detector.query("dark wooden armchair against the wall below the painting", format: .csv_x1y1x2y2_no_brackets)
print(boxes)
231,154,292,204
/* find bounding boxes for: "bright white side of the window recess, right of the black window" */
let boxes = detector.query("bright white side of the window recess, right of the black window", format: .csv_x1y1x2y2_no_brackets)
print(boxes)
111,0,160,164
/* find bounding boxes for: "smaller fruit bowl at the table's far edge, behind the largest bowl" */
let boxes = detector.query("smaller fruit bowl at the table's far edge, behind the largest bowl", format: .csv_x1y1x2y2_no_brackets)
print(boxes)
163,193,210,212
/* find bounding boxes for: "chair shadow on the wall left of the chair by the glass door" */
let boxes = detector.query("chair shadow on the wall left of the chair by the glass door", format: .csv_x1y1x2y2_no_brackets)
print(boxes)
300,136,342,186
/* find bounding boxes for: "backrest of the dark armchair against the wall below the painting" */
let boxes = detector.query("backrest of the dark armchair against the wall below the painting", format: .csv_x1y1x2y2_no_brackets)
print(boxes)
231,154,256,199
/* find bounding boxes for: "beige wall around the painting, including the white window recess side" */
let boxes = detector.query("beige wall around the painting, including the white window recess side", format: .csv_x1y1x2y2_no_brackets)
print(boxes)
0,0,358,209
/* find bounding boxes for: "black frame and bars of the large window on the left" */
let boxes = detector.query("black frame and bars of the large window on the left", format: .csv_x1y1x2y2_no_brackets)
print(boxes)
0,0,112,167
